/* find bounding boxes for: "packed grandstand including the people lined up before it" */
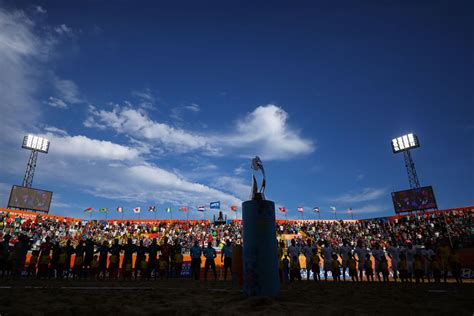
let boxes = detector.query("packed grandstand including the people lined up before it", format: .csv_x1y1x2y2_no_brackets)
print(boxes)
0,207,474,282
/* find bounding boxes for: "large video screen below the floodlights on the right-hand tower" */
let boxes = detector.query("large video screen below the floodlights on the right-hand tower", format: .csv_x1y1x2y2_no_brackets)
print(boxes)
392,186,437,213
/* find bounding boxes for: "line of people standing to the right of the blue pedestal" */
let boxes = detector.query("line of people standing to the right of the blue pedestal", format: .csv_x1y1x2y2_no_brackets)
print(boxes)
279,239,462,283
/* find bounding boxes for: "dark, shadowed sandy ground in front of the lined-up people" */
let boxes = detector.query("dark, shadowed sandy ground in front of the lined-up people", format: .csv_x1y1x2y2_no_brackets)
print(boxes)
0,279,474,316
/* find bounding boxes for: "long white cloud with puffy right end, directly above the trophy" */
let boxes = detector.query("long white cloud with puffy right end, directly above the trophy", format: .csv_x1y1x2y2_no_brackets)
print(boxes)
84,105,315,160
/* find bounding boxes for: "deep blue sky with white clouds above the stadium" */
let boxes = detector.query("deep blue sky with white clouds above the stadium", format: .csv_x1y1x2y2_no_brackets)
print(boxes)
0,1,474,219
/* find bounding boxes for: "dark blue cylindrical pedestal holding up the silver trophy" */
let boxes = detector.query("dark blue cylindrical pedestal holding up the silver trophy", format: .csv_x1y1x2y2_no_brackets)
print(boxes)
242,200,280,296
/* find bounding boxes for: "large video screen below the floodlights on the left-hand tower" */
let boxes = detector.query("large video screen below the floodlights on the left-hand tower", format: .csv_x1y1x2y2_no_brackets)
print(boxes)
8,185,53,213
